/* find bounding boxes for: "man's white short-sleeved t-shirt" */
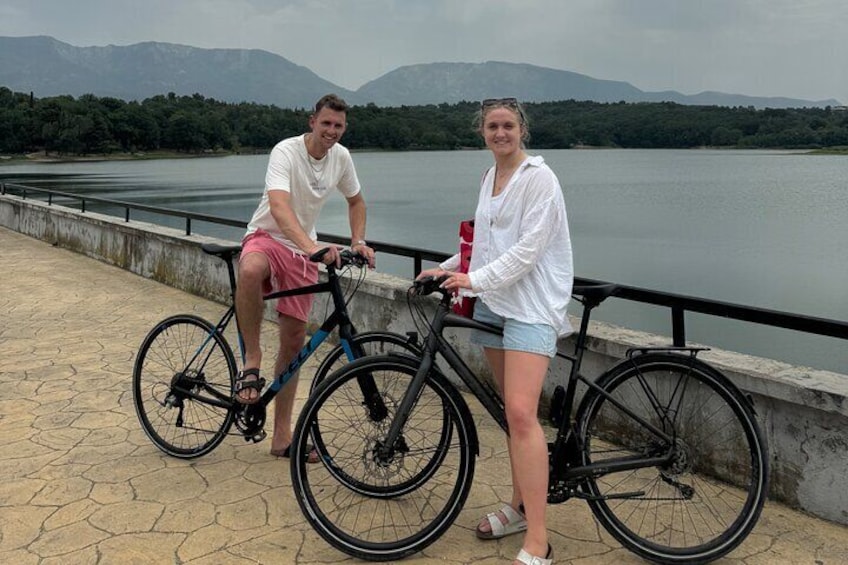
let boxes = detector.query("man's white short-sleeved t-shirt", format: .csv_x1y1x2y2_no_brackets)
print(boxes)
247,134,360,252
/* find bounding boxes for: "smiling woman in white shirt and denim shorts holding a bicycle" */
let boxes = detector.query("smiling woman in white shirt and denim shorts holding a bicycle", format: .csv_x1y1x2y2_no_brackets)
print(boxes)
419,98,573,564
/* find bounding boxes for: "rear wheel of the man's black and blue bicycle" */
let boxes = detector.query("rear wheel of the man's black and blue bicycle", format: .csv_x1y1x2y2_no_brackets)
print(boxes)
133,314,237,459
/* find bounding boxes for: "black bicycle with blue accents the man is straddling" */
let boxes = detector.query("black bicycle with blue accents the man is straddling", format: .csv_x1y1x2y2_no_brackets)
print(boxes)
133,244,420,459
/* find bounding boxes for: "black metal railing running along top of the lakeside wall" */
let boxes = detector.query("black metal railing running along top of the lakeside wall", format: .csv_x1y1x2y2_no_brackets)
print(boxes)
0,183,848,346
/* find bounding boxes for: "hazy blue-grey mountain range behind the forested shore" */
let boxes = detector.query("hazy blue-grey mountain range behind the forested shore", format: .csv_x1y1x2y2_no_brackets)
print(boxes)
0,36,841,108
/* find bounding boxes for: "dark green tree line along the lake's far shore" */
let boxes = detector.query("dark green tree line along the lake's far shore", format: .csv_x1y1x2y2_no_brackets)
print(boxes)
0,87,848,155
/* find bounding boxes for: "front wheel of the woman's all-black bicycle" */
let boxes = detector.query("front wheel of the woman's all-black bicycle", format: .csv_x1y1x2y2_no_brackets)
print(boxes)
291,356,478,561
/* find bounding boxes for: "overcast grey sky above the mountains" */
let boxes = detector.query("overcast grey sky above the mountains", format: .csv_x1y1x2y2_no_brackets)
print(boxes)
0,0,848,104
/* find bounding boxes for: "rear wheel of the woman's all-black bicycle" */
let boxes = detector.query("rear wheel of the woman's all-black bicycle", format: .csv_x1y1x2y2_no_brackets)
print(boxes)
577,352,768,563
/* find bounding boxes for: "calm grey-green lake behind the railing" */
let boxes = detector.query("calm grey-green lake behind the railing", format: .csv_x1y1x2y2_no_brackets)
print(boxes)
0,149,848,372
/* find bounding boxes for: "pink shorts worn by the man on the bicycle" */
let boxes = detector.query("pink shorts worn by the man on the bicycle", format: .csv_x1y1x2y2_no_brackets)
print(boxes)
241,230,318,322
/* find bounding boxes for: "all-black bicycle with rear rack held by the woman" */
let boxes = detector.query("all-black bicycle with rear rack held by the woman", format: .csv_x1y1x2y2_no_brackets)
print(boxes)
291,278,768,563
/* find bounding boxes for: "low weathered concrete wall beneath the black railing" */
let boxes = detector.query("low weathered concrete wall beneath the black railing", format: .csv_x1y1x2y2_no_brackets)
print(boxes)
0,195,848,524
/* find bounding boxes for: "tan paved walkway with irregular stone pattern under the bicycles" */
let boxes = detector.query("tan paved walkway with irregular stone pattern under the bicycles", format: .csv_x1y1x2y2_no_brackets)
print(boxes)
0,228,848,565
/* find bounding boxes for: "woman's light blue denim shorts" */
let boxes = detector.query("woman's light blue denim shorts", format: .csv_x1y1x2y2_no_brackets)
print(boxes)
471,298,557,357
